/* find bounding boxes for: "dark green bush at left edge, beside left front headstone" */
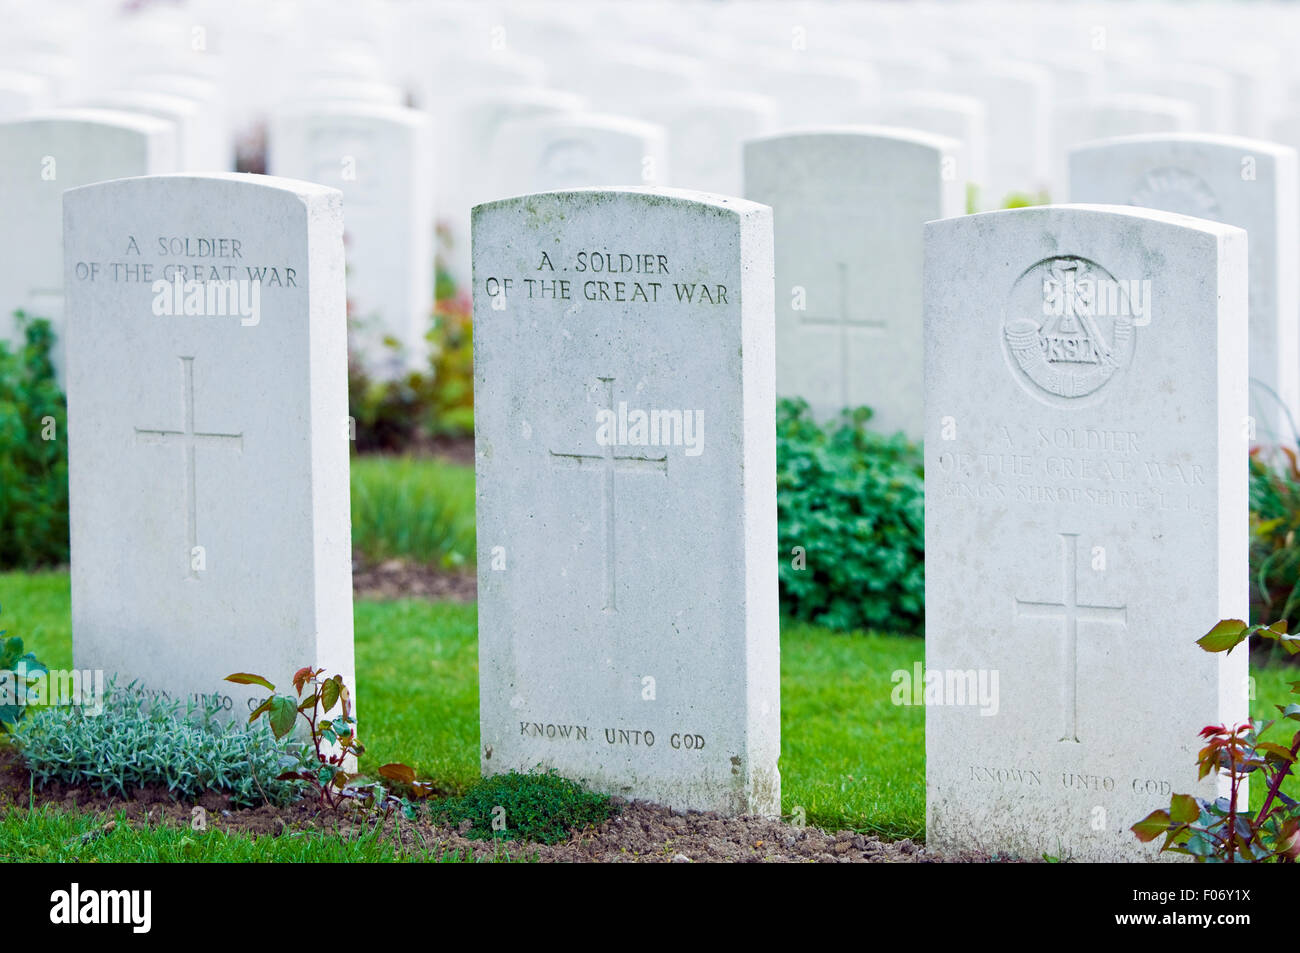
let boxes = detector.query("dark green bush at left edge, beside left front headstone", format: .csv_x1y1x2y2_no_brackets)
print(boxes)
0,312,68,569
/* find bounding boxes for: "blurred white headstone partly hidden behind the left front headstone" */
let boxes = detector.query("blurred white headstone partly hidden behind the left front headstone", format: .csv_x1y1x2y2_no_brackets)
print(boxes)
267,103,434,377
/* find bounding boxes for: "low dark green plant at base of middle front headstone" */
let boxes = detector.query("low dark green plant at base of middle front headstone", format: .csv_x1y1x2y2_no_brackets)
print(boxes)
430,771,615,844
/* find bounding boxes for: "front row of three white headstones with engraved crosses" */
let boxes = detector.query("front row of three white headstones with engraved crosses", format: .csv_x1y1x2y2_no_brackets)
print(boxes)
55,156,1249,859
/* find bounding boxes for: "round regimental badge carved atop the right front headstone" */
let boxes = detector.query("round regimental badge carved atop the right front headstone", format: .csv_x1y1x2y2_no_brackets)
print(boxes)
1002,256,1134,400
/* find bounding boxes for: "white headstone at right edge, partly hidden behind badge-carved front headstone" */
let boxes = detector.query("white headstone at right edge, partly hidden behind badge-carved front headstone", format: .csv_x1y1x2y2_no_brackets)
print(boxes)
1070,135,1300,445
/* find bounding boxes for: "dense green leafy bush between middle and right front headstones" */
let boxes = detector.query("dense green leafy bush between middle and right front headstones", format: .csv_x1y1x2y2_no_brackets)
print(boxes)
776,400,926,632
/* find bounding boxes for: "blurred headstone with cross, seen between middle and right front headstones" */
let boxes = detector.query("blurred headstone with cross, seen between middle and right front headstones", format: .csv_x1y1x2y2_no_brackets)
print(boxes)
745,126,966,438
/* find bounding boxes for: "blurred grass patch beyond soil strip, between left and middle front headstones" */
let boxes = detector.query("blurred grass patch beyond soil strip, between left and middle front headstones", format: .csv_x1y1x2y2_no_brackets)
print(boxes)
352,456,475,568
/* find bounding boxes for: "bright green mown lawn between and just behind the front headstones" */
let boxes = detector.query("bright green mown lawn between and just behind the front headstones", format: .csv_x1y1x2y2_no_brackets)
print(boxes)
0,572,1296,859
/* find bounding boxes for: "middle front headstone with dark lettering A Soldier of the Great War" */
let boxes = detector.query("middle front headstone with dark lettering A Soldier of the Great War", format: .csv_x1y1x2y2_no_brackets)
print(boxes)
473,190,780,814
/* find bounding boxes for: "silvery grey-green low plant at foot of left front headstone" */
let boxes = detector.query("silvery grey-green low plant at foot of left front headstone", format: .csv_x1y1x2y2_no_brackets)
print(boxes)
13,683,302,806
